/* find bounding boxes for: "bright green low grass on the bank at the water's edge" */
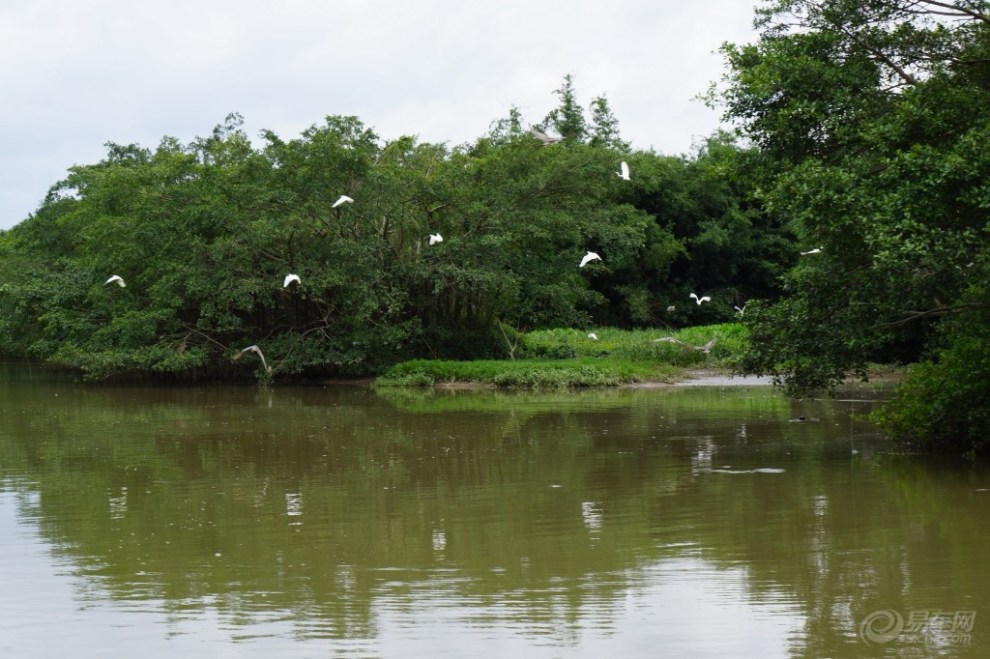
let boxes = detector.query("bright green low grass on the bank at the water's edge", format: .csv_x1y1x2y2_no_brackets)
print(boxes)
375,323,746,389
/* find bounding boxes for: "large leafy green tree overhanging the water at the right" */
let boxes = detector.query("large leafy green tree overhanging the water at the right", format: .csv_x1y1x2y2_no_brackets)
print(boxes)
722,0,990,451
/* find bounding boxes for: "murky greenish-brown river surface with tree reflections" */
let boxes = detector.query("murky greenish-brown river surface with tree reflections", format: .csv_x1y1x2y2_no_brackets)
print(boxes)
0,364,990,659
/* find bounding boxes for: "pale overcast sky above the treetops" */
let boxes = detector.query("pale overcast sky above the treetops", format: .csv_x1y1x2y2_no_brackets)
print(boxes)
0,0,755,228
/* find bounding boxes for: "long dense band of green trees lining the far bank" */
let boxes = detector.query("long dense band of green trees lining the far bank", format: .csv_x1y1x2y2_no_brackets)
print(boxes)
0,76,793,378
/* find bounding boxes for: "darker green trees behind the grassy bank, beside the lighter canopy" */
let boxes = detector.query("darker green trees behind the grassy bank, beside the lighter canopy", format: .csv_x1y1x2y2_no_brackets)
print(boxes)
593,134,795,327
